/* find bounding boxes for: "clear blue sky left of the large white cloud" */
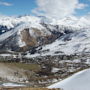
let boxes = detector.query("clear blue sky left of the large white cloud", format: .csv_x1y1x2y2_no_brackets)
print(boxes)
0,0,36,15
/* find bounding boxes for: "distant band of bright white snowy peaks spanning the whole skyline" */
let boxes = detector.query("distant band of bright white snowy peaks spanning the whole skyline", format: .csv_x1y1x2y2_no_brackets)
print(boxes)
0,15,90,28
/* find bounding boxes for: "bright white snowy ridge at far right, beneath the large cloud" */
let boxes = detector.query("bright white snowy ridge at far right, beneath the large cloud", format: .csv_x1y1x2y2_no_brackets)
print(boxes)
54,16,90,28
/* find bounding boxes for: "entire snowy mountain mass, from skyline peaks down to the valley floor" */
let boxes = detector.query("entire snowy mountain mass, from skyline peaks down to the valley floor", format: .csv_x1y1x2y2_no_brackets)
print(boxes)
0,16,90,57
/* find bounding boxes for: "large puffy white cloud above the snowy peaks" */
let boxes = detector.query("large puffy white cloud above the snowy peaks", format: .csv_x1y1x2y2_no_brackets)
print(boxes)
32,0,87,19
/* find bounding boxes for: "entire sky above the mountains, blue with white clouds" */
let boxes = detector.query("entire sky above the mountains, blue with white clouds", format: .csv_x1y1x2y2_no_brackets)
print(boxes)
0,0,90,18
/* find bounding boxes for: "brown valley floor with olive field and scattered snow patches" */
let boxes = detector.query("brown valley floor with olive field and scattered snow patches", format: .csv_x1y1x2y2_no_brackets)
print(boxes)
0,55,90,88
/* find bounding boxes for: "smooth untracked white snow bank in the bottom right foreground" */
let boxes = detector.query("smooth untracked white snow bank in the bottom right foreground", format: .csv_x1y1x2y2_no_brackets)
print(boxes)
48,69,90,90
